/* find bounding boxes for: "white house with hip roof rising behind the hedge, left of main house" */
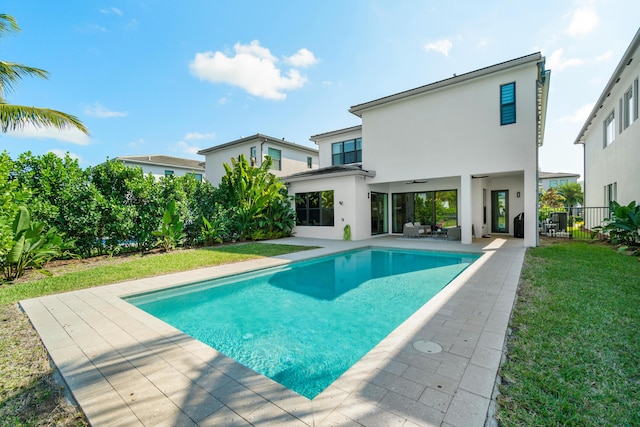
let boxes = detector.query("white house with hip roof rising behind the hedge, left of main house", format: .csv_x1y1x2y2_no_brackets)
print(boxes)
198,133,318,186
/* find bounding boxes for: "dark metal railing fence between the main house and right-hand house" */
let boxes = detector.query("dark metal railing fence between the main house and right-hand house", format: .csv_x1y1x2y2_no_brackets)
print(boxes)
539,206,610,239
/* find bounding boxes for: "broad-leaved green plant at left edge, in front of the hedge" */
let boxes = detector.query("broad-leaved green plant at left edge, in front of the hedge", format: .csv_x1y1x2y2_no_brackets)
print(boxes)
0,206,73,281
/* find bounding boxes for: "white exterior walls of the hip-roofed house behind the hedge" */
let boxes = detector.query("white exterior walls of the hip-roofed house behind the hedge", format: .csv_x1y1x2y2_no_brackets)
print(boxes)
205,140,318,186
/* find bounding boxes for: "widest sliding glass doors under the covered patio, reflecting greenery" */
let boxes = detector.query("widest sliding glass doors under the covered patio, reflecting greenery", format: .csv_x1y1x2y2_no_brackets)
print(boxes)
392,190,458,233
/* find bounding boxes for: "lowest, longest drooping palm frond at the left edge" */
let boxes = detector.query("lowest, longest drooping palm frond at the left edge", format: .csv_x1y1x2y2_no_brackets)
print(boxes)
0,103,89,135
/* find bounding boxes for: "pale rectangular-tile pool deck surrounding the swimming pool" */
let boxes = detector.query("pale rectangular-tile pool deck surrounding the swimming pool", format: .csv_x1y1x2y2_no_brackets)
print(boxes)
20,236,525,427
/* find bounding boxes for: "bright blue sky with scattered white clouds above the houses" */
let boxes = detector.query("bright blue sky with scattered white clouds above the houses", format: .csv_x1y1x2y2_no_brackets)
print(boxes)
0,0,640,177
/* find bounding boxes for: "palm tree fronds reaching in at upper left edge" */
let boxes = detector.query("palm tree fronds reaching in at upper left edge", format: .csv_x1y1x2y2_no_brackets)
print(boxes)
0,14,89,135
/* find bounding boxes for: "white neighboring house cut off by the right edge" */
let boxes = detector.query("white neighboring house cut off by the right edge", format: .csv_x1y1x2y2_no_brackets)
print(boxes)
575,26,640,207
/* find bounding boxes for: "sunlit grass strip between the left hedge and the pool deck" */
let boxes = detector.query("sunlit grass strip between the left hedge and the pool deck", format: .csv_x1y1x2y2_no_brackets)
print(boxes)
0,243,311,426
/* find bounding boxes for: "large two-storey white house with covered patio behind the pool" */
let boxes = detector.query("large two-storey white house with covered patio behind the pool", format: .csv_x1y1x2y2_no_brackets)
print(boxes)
284,53,550,246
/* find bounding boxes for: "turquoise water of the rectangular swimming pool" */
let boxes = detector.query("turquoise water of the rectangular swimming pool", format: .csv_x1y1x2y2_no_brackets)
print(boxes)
126,248,479,399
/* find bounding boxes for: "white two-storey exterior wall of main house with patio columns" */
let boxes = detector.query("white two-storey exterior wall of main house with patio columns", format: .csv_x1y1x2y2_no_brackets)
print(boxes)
362,63,538,246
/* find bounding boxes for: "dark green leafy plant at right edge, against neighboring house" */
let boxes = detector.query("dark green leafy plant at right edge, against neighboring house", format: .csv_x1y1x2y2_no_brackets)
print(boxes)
591,201,640,253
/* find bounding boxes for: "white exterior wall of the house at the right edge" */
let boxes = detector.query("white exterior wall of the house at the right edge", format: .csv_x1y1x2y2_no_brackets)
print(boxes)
584,43,640,207
